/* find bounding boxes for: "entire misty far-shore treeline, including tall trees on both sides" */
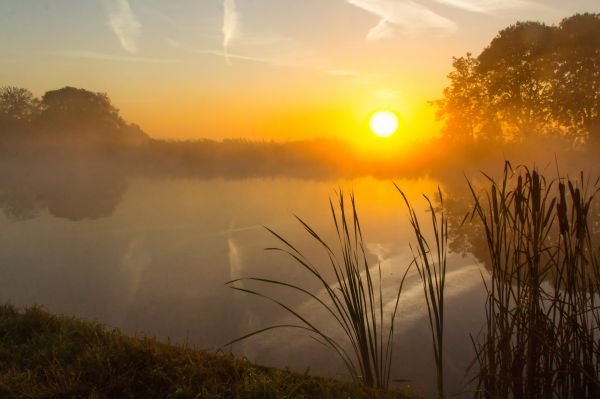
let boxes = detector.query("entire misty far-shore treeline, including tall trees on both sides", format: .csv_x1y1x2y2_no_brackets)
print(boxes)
0,14,600,178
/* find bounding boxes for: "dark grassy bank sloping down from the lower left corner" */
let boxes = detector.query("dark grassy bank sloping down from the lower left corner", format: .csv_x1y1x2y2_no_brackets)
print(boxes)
0,305,416,399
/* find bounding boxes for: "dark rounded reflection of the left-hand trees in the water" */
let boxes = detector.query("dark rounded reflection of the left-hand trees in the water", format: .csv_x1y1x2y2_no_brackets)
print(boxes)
0,159,127,220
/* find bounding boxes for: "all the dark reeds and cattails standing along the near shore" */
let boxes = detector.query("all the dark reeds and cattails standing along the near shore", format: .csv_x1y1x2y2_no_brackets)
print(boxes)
229,162,600,399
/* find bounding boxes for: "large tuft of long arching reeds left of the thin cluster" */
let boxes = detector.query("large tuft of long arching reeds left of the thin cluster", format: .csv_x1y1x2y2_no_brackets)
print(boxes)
226,192,409,389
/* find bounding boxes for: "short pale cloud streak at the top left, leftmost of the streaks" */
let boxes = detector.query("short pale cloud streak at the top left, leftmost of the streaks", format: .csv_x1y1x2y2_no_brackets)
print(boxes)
108,0,142,53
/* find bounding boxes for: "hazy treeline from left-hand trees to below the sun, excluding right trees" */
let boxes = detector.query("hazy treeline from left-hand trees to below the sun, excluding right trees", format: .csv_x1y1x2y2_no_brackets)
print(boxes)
0,87,436,179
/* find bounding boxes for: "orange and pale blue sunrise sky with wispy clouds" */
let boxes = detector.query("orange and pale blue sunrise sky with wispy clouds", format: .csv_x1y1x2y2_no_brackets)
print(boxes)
0,0,600,141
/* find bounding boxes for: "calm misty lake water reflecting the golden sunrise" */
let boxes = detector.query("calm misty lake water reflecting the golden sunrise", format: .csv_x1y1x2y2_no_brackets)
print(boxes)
0,171,484,393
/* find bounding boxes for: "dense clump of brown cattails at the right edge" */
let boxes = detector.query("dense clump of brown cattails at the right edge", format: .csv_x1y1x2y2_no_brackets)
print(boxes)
469,163,600,398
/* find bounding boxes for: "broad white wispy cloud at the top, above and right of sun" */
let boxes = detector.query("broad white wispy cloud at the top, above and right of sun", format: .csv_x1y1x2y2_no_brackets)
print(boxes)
346,0,458,40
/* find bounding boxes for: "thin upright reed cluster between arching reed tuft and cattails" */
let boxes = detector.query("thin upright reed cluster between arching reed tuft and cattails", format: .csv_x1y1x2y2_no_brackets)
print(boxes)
394,188,448,398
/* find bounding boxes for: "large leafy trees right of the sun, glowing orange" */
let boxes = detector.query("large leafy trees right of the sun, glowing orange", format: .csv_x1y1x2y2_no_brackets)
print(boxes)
435,13,600,143
